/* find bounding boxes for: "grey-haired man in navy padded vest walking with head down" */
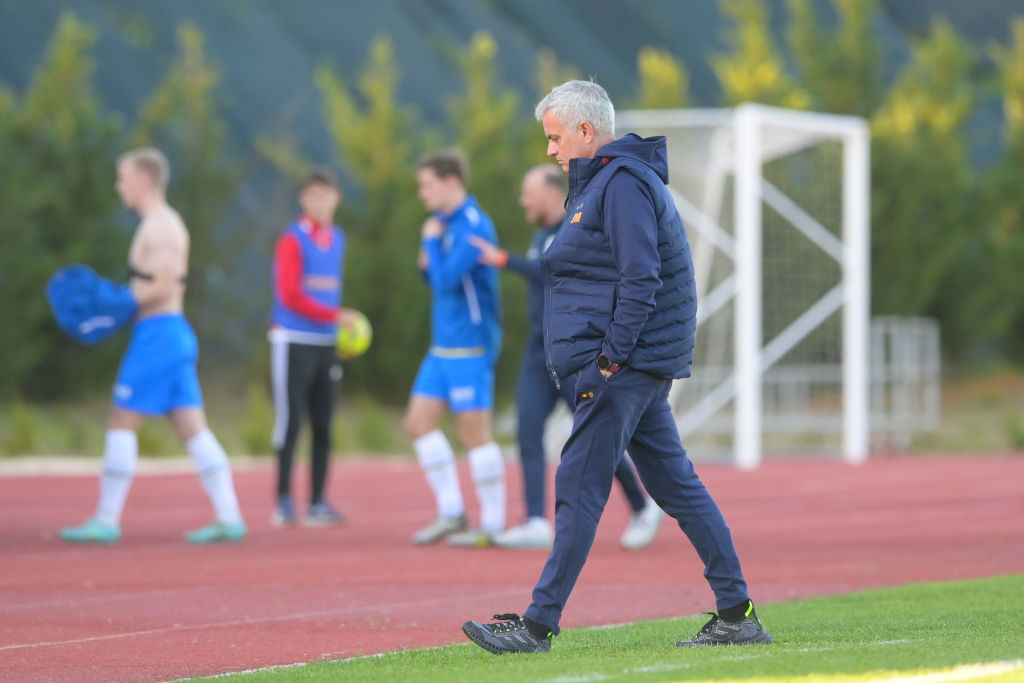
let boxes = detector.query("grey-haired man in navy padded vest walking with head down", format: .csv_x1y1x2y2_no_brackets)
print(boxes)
463,81,771,654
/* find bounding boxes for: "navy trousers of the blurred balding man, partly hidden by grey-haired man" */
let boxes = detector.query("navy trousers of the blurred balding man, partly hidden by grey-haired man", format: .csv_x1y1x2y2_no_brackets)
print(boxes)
516,346,646,517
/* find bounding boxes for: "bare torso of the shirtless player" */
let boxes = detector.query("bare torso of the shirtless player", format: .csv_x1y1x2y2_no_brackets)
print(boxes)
128,204,189,318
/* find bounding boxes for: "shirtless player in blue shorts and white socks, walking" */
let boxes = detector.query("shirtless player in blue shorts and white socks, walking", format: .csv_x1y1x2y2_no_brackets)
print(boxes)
60,147,246,543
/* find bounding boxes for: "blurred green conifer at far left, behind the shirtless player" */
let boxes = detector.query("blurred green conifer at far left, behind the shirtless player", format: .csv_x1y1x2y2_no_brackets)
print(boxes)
0,14,128,398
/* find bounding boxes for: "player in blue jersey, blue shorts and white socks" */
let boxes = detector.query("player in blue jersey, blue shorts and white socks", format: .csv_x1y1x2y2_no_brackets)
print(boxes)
404,150,505,547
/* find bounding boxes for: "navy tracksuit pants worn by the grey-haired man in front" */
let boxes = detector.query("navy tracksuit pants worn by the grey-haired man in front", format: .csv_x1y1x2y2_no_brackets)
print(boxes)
524,362,749,634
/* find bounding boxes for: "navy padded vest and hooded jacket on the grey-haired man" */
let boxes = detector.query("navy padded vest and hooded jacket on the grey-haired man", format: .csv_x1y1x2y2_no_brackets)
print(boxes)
541,133,697,378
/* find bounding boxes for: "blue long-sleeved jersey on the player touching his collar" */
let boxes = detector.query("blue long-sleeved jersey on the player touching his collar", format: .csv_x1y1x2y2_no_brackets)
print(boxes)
423,197,502,359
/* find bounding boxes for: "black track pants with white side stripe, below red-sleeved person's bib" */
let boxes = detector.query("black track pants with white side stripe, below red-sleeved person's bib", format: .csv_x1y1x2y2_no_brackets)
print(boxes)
270,341,341,502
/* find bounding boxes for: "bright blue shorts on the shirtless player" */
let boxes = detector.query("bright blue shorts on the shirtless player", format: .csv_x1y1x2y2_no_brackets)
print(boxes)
114,313,203,415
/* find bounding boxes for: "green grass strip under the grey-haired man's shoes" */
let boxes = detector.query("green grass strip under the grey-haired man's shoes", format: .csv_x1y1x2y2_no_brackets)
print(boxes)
190,574,1024,683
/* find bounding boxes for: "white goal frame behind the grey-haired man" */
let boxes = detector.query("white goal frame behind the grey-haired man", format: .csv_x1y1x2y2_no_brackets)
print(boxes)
616,103,870,469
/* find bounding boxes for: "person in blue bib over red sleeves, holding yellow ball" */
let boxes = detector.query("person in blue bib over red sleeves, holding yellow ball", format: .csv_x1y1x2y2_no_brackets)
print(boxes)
268,169,352,526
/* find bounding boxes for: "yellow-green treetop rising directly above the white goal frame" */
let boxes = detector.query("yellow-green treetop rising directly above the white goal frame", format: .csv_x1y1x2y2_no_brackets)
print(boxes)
712,0,811,109
